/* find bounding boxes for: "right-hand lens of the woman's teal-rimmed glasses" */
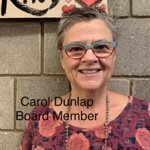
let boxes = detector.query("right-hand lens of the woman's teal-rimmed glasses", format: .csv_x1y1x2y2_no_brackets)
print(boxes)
94,43,113,57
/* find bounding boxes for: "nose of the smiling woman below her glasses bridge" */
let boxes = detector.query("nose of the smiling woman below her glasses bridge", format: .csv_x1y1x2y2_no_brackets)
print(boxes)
82,49,98,62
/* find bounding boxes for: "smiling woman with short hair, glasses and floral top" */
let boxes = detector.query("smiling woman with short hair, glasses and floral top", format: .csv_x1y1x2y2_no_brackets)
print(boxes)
21,8,150,150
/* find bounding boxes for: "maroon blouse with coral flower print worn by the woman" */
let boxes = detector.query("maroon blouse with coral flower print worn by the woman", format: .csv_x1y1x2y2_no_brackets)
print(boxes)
20,97,150,150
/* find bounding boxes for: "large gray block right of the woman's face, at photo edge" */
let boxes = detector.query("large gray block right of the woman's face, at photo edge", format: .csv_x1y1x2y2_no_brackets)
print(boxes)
114,18,150,76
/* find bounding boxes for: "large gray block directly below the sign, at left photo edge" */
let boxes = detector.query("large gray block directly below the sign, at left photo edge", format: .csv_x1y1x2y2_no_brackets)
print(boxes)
0,22,41,75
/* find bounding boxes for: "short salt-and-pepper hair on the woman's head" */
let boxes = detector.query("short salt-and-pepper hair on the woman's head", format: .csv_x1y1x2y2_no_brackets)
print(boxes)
57,7,118,50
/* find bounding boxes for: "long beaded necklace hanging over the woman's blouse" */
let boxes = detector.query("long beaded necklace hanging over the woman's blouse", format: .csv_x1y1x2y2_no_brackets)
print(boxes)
65,92,109,150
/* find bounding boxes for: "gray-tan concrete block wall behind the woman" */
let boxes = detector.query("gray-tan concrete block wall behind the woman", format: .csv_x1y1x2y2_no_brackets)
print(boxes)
0,0,150,150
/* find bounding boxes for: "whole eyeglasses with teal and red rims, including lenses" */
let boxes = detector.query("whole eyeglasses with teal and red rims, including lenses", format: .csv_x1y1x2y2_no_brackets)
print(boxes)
63,41,117,59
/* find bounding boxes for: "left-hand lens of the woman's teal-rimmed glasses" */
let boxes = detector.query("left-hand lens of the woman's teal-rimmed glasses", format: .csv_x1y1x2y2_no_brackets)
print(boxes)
66,45,85,58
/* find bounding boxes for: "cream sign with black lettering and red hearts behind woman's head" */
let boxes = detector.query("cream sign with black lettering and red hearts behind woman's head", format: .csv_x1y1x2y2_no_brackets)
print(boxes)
0,0,107,19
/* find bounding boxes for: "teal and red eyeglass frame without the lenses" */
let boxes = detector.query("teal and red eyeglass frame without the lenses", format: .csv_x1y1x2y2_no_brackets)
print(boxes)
63,41,117,58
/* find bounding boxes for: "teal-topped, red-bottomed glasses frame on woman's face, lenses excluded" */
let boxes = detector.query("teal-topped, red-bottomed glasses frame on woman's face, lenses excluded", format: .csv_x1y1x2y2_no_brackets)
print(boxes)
63,41,117,59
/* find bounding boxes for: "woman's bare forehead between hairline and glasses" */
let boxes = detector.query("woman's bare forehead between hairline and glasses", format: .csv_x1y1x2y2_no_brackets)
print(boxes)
64,19,113,44
